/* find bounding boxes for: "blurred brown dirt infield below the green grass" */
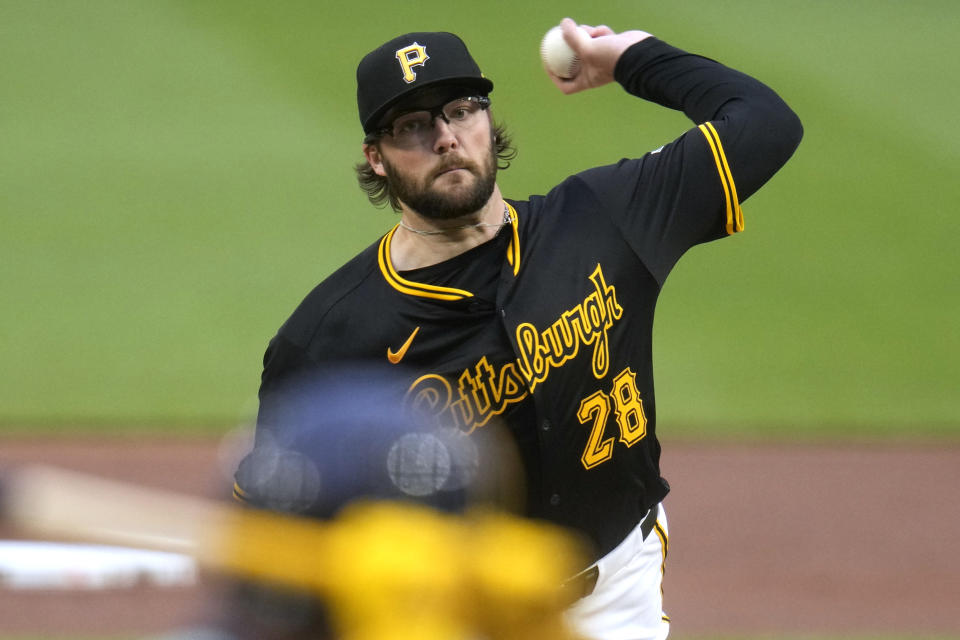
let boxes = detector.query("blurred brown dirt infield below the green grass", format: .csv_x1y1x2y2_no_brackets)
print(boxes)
0,438,960,638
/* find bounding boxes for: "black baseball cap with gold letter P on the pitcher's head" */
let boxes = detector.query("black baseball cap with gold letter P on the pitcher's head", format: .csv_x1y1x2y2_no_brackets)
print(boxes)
357,31,493,134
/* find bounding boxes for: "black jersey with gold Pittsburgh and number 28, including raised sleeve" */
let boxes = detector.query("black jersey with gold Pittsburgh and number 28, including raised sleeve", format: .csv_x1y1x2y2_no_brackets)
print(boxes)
241,38,802,557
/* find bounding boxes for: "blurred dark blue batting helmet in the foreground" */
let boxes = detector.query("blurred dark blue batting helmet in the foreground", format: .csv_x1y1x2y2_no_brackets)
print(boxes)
234,363,488,519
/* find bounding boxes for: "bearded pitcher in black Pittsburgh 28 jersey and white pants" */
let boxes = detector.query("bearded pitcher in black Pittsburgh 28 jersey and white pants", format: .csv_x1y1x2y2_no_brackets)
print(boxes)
238,19,803,640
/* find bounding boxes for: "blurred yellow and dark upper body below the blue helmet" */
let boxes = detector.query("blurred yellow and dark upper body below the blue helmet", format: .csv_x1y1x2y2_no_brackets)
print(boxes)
172,501,580,640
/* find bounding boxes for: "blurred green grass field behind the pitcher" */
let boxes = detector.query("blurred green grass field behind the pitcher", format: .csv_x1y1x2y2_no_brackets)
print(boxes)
0,0,960,438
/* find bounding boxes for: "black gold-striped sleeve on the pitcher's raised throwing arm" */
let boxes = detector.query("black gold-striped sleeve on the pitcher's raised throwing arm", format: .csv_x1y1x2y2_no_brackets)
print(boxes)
577,38,803,284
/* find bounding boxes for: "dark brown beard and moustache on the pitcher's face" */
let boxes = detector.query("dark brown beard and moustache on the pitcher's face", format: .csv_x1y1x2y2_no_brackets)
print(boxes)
382,142,497,220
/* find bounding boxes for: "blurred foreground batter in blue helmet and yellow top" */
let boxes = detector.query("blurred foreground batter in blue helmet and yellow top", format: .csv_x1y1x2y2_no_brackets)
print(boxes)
155,368,585,640
